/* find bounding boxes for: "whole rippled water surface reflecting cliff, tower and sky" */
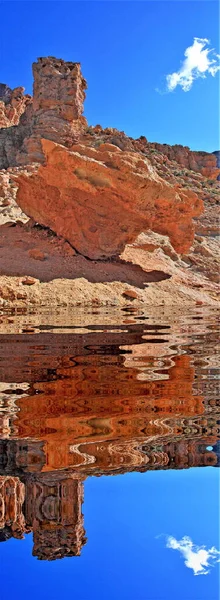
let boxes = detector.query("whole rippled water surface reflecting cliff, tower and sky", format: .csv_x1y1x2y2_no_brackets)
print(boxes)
0,308,220,600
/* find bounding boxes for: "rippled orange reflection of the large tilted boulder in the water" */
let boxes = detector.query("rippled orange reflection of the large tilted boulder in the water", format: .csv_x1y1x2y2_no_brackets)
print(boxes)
3,355,215,471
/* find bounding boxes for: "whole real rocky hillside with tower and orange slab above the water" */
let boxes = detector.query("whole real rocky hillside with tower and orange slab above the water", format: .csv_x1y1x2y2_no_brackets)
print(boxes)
0,57,220,305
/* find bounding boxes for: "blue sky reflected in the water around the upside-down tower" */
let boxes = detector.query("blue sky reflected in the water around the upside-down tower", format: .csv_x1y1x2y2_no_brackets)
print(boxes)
0,467,219,600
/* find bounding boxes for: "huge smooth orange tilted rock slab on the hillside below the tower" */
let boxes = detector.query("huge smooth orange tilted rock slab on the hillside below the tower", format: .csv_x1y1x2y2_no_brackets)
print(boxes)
14,140,202,259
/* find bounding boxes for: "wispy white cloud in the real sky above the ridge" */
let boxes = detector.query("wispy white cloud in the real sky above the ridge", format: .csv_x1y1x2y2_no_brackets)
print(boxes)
166,38,220,92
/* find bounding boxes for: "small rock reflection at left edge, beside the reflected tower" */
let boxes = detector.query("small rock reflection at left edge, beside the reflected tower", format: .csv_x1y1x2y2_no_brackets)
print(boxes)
0,475,25,541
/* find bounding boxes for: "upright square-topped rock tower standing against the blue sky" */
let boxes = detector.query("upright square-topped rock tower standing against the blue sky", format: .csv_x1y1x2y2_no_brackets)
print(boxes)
33,57,87,146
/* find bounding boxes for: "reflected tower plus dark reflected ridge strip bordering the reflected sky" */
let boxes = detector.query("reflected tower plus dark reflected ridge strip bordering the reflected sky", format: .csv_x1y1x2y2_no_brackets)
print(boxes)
0,428,219,560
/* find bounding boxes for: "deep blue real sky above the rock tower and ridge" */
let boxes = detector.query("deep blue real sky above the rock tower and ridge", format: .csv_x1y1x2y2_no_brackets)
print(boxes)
0,0,219,152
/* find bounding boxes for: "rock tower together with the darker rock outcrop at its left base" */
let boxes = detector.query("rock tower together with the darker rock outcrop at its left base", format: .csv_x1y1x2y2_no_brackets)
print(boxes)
0,57,86,169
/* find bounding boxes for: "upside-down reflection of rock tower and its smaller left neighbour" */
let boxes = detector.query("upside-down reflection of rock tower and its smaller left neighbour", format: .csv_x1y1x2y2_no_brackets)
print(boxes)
0,472,86,560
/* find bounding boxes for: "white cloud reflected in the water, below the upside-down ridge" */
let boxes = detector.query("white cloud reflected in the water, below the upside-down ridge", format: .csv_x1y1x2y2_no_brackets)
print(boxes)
166,536,220,575
